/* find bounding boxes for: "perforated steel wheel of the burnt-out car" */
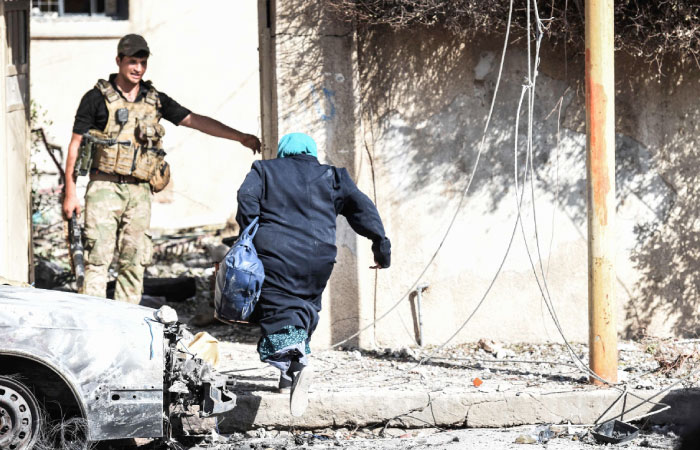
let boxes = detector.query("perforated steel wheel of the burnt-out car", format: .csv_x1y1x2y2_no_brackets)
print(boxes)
0,376,41,450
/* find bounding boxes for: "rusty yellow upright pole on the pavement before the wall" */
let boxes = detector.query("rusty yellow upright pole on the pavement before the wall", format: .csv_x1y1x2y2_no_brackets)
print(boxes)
585,0,617,384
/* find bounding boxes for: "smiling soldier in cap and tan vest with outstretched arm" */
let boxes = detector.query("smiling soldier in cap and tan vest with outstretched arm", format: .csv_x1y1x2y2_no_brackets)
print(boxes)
63,34,260,303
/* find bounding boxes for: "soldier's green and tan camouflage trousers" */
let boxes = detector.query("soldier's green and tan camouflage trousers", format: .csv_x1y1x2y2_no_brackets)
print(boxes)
81,181,153,303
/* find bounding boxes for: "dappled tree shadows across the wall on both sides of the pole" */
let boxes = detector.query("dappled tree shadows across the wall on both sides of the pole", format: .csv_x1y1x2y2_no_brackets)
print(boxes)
358,27,700,337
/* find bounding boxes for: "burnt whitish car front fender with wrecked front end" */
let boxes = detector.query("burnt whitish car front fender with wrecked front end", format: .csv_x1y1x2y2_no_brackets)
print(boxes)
0,286,235,441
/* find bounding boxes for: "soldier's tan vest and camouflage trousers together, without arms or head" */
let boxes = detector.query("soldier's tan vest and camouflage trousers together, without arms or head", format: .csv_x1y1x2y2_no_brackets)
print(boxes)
74,75,175,303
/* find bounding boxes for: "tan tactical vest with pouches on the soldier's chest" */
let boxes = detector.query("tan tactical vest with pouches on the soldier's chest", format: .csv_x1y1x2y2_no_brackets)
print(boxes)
92,80,165,181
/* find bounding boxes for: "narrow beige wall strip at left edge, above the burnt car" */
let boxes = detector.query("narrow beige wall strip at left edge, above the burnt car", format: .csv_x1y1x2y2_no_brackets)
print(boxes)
0,0,33,281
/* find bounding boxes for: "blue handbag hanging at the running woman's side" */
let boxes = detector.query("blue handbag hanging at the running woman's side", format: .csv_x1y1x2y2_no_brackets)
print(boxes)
214,217,265,321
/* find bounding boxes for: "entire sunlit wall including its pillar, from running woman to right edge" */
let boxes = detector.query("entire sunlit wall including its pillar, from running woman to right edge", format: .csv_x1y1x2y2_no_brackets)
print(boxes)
264,2,700,346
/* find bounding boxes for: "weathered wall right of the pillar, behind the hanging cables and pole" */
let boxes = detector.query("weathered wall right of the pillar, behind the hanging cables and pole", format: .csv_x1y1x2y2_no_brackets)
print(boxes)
360,30,699,343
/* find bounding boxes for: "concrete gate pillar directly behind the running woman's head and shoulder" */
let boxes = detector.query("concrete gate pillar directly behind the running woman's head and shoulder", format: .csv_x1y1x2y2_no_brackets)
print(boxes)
260,0,374,346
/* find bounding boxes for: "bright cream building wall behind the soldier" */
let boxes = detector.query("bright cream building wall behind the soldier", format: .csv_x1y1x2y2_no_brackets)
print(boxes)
31,0,260,228
